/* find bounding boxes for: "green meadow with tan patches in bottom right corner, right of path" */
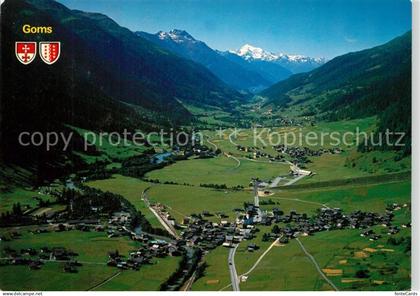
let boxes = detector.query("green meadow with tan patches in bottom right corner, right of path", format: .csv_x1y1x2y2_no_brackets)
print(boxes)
301,227,411,291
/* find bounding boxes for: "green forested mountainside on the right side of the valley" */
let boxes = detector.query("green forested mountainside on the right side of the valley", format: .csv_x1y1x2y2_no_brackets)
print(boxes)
261,32,411,153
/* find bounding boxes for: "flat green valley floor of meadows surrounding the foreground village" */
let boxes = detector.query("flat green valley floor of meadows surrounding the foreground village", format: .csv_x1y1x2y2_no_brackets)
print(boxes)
0,122,411,291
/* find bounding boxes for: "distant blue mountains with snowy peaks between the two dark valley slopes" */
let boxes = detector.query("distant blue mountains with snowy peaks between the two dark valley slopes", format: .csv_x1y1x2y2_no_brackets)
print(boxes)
136,29,325,93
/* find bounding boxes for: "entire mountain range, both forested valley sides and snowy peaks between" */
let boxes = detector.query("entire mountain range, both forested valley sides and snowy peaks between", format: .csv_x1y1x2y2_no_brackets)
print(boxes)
0,0,411,180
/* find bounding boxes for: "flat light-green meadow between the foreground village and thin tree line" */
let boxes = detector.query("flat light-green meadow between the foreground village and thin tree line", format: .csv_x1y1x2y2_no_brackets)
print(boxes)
87,175,321,227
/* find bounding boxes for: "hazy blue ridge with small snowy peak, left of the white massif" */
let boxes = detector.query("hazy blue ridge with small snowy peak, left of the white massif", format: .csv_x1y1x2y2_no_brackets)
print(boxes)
136,30,272,91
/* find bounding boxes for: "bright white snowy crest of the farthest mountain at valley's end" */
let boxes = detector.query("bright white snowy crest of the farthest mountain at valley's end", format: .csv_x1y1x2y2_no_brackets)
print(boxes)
233,44,325,64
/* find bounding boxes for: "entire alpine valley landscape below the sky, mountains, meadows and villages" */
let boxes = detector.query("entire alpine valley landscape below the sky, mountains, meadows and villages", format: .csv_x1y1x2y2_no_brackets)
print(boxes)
0,0,412,291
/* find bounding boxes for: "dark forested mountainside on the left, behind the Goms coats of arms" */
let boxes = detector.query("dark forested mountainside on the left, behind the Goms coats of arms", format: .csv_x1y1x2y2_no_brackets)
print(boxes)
1,0,243,180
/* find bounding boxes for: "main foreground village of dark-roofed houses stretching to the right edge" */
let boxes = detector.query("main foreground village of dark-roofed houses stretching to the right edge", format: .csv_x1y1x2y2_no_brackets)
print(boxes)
145,180,411,252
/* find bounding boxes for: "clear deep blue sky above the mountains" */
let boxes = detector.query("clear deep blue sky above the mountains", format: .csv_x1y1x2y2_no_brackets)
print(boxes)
58,0,411,59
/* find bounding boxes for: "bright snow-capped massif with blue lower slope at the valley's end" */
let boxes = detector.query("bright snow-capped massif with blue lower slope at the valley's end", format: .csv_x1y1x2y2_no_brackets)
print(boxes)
229,44,326,73
